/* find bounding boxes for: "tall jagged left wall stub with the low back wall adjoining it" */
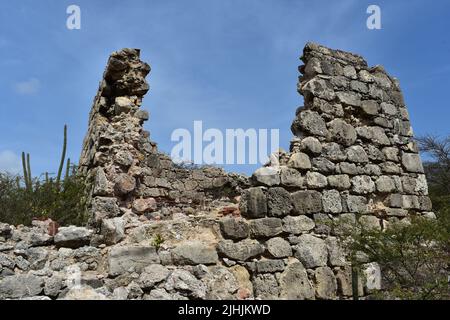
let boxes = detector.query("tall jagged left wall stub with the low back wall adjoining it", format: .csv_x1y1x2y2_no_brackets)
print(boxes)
79,49,246,235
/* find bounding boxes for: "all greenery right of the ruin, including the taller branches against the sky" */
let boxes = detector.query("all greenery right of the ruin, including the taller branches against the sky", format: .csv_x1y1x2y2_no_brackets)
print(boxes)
341,136,450,299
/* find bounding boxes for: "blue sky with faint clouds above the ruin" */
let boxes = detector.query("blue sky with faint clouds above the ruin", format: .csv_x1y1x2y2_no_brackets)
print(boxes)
0,0,450,175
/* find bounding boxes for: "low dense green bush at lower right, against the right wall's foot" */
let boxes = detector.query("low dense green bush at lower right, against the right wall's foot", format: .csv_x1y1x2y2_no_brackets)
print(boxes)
348,217,450,300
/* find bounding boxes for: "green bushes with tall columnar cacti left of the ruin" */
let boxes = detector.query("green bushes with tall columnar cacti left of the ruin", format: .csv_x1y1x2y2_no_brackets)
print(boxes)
0,126,86,225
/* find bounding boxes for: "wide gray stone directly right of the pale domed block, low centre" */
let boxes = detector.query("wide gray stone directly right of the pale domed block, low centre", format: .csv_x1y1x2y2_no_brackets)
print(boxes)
217,239,264,261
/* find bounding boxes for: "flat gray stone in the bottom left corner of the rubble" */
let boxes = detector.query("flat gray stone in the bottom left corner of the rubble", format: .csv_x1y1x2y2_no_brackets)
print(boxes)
0,274,44,299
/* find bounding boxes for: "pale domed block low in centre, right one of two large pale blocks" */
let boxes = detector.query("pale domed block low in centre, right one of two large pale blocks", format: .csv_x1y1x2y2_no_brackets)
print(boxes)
172,241,218,265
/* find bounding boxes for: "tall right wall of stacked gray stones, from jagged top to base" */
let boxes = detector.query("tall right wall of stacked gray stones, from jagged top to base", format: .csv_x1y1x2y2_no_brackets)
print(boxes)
229,43,434,299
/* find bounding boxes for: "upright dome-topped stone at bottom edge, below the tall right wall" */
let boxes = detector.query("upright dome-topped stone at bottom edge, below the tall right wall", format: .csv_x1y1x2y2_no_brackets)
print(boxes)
280,260,314,300
